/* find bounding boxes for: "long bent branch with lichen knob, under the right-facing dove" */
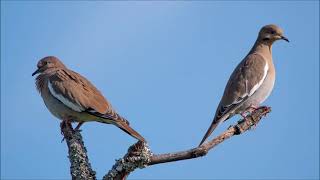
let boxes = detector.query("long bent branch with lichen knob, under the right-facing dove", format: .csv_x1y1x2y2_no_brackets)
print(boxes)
103,107,271,180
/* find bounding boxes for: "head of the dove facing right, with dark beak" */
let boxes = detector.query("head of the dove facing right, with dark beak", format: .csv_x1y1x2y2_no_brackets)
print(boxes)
258,24,289,45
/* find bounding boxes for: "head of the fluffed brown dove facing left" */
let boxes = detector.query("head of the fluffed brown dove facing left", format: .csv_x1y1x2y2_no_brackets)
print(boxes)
32,56,66,76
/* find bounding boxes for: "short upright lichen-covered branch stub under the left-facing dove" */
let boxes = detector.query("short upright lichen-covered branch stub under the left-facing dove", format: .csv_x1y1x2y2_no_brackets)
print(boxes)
61,121,96,180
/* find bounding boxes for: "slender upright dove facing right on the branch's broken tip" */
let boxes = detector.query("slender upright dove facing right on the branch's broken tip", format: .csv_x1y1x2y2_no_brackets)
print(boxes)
199,24,289,146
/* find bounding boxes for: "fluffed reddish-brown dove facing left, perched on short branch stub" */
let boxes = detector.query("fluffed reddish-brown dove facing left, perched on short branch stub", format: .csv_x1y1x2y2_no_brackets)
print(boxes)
32,56,146,142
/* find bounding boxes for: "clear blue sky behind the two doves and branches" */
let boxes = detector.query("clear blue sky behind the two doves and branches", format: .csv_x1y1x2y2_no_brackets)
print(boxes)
1,1,319,179
